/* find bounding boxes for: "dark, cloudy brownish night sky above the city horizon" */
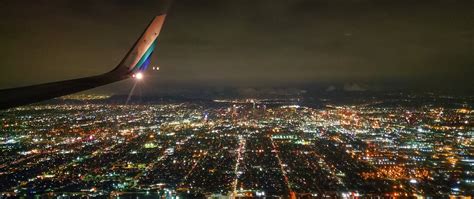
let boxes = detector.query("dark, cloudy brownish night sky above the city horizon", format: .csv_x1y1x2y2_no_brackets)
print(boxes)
0,0,474,91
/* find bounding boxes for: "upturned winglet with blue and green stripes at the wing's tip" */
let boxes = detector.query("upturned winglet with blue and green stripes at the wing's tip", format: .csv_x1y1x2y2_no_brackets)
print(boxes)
111,14,166,75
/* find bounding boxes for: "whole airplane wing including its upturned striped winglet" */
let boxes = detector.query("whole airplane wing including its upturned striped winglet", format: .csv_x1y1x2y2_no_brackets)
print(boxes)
0,14,166,110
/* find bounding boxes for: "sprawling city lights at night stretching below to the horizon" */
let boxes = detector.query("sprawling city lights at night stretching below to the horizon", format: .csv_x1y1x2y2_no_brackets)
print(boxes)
0,95,474,198
